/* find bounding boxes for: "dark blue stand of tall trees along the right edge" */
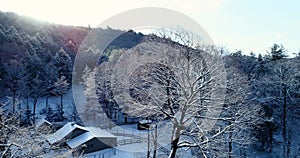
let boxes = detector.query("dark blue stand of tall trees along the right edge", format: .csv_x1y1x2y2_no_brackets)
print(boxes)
226,44,300,157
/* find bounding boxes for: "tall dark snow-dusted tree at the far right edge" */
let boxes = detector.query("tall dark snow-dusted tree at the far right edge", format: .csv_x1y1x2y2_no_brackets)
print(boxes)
266,59,299,157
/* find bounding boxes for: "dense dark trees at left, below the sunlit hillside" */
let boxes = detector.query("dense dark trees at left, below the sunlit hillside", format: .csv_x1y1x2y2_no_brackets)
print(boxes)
3,49,72,123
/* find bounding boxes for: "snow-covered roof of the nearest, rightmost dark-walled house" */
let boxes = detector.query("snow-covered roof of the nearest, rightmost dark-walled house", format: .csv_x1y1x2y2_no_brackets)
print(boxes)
67,127,117,149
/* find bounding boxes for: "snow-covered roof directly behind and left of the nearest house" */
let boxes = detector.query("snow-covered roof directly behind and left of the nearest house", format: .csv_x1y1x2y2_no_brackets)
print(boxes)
47,122,87,144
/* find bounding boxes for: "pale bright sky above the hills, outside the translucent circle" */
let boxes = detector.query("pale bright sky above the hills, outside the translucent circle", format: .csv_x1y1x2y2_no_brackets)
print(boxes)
0,0,300,54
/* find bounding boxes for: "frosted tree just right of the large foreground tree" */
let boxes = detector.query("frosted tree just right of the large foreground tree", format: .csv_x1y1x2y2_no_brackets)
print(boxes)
221,56,264,157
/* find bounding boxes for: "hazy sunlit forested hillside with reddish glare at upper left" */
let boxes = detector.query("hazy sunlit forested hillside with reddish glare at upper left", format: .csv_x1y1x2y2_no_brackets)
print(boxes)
0,12,89,58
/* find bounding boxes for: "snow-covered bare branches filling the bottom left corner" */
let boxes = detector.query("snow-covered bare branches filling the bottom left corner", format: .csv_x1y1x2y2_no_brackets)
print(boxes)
0,109,73,157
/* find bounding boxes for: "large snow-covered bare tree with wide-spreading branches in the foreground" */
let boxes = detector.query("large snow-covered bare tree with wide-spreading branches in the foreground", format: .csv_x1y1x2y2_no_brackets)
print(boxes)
107,30,259,158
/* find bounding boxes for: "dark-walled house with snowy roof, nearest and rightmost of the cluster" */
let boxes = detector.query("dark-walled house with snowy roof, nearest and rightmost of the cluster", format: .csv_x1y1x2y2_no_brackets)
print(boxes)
66,127,117,153
